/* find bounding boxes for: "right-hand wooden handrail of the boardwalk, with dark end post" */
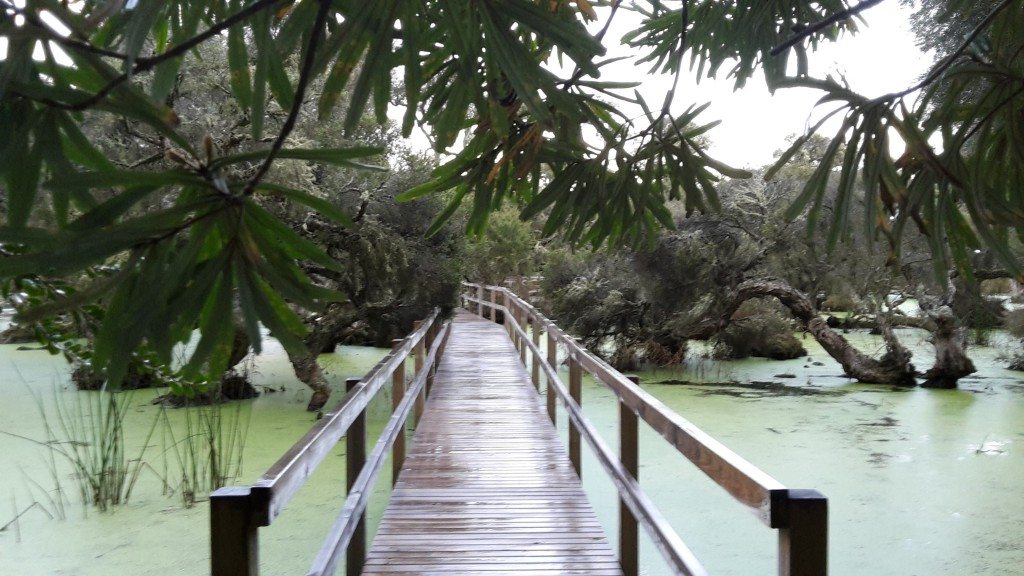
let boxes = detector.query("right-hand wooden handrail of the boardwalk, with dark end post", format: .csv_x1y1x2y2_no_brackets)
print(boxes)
463,283,827,576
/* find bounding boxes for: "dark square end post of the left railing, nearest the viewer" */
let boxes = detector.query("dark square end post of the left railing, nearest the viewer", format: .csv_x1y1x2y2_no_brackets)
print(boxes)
210,486,259,576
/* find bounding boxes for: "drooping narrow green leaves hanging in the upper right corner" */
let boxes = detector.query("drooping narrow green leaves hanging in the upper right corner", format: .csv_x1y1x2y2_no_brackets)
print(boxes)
778,0,1024,278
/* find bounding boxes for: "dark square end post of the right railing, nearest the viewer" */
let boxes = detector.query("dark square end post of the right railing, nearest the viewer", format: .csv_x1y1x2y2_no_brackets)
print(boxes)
778,489,828,576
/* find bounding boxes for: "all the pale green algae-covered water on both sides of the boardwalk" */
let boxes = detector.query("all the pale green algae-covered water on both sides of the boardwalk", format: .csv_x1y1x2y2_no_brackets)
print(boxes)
0,331,1024,576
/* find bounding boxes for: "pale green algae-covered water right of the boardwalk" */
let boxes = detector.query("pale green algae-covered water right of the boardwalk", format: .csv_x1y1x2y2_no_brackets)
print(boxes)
584,330,1024,576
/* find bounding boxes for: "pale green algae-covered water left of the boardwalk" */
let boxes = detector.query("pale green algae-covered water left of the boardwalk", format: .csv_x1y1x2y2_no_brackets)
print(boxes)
0,336,389,576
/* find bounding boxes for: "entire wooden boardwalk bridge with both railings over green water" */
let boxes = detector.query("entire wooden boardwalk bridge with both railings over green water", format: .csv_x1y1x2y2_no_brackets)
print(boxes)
210,284,827,576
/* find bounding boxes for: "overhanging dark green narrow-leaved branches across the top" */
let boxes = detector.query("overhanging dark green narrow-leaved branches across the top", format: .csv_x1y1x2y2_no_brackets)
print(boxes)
0,0,1024,379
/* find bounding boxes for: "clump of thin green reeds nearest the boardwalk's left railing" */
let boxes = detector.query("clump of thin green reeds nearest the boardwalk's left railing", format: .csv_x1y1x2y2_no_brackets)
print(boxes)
160,402,250,507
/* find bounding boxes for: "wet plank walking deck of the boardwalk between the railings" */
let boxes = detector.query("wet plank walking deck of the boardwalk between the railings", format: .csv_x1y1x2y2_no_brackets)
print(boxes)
364,313,622,576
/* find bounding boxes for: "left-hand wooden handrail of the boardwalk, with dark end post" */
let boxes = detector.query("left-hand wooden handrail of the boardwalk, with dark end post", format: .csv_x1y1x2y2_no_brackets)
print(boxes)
210,308,451,576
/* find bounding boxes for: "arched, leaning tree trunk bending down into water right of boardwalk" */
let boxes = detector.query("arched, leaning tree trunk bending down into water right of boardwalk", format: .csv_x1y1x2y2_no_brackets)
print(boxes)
688,280,916,386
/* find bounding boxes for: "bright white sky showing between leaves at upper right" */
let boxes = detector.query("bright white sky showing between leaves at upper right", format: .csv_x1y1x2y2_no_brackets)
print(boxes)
604,0,932,168
